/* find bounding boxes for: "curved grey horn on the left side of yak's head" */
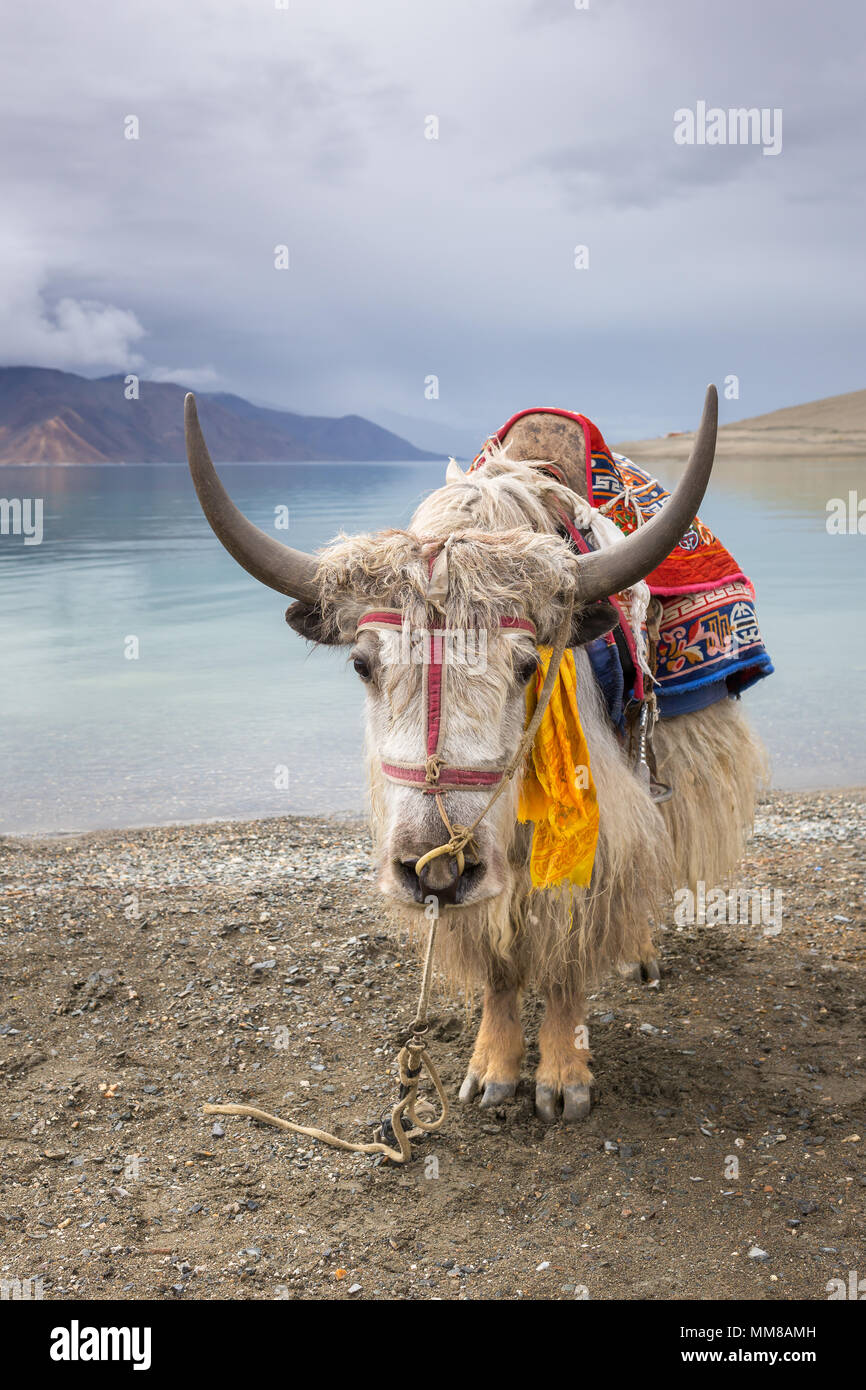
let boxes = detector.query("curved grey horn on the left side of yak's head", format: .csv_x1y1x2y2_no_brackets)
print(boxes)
183,391,318,605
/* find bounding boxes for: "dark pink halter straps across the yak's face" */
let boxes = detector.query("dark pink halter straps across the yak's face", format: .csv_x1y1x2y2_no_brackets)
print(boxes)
357,609,537,795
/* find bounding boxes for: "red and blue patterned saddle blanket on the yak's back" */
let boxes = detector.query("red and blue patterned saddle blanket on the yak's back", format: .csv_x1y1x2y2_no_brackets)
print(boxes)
475,411,773,724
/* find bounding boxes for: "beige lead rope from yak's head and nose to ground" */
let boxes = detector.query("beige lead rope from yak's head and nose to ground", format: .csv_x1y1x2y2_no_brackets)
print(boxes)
203,599,574,1163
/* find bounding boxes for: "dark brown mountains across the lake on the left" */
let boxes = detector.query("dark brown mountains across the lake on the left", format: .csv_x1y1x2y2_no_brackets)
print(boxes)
0,367,442,464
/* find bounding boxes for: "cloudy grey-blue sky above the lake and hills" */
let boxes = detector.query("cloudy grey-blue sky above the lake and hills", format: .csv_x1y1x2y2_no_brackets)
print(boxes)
0,0,866,450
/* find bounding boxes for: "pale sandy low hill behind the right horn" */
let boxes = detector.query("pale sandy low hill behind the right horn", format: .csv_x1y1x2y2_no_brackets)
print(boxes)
614,391,866,464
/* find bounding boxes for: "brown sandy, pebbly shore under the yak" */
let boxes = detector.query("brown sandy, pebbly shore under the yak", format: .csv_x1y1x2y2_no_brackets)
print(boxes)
0,791,866,1300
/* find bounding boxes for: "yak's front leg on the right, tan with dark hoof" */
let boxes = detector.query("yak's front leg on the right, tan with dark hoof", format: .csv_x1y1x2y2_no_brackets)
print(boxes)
535,990,592,1123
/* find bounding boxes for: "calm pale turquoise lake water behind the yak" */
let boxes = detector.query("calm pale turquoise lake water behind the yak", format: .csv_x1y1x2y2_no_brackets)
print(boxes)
0,463,866,833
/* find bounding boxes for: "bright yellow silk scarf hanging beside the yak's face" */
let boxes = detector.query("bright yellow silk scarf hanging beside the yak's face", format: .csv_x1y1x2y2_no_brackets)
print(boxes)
517,646,598,888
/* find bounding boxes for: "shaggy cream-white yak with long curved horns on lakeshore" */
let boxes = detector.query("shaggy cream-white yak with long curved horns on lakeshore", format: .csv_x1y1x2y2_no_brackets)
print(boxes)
185,388,765,1122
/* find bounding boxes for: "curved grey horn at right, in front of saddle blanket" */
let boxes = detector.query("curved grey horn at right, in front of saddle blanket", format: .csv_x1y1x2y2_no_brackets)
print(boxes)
575,386,719,603
